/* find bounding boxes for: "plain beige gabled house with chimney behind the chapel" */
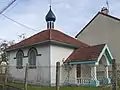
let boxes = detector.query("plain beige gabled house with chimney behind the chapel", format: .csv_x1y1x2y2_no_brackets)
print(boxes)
76,8,120,64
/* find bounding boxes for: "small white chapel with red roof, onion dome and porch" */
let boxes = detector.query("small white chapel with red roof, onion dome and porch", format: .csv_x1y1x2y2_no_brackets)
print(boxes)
7,8,113,86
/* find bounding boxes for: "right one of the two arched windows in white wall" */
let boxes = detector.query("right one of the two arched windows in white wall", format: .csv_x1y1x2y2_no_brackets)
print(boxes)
28,48,37,68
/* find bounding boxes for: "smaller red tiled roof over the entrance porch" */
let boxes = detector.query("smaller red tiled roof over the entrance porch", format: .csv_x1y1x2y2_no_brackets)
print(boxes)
65,44,105,62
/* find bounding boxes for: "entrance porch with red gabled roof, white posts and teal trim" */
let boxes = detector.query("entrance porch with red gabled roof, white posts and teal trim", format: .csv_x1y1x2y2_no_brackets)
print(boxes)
64,44,113,86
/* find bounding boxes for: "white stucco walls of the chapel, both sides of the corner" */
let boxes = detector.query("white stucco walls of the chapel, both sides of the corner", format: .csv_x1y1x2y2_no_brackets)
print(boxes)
9,45,76,85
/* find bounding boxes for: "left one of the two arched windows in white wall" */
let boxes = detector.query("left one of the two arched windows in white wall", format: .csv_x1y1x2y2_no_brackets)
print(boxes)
16,50,24,69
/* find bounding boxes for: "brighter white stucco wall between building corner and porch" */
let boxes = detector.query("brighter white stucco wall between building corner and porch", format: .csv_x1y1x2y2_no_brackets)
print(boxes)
50,45,75,84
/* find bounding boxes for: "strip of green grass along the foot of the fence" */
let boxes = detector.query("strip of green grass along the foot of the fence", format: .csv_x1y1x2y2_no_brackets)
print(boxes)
7,83,113,90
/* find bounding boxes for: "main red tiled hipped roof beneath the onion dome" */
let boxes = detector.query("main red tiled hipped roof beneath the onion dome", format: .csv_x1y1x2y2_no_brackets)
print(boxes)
8,29,88,50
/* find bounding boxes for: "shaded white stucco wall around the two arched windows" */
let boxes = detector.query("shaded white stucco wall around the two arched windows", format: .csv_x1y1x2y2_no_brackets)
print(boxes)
9,45,50,83
